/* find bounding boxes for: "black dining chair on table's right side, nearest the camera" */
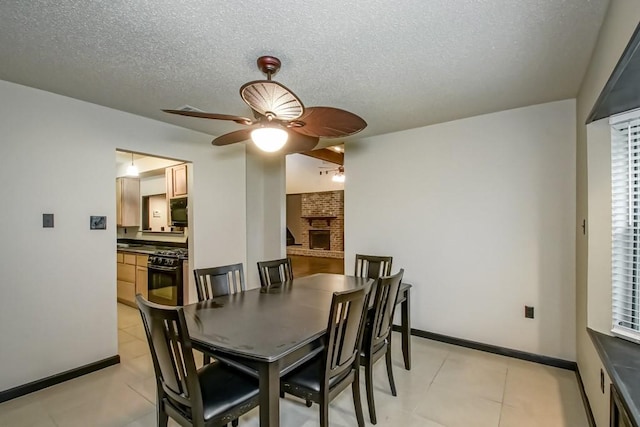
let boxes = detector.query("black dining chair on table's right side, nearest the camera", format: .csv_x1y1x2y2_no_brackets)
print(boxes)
280,287,369,427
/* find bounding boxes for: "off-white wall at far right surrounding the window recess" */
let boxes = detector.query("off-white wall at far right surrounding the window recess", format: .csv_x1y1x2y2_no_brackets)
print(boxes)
576,0,640,426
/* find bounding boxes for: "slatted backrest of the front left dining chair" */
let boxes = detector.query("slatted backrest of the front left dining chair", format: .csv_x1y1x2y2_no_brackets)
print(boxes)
136,294,203,419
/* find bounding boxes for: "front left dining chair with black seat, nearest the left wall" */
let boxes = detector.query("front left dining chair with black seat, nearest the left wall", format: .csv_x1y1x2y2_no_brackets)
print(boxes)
136,294,258,427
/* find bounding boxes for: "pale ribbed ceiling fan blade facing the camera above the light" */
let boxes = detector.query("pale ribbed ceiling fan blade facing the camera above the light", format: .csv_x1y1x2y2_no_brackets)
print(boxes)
240,80,304,120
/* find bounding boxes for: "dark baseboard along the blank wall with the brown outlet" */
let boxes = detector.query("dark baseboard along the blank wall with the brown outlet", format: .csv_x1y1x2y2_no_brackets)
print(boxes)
393,325,578,371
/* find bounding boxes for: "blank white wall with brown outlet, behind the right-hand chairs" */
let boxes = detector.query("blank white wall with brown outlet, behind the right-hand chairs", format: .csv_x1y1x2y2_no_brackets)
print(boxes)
345,100,575,360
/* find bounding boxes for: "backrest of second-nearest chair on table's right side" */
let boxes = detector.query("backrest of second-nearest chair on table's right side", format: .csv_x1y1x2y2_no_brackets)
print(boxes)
367,269,404,351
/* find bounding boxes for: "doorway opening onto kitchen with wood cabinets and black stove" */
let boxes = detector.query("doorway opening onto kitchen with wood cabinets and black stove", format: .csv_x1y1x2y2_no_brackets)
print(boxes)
112,150,192,357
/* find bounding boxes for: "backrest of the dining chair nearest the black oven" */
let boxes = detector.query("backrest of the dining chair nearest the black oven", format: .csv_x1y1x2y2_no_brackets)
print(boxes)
193,263,245,301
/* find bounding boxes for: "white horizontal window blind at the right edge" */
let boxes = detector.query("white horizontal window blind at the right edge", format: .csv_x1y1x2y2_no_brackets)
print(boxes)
610,112,640,342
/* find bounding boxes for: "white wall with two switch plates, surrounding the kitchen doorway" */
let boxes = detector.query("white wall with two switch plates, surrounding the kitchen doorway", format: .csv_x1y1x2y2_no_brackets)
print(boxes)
0,81,246,390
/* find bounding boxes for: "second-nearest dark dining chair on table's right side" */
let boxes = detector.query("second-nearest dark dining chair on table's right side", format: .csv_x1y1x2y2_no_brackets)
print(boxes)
360,269,404,424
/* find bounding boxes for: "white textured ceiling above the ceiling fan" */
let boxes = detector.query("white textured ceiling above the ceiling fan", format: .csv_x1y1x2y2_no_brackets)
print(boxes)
0,0,608,145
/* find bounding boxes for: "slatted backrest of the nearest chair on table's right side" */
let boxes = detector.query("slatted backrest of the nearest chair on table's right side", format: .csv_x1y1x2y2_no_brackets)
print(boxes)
324,286,370,387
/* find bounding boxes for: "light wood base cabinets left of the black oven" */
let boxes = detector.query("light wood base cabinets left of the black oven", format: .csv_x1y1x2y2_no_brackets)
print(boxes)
116,251,149,307
